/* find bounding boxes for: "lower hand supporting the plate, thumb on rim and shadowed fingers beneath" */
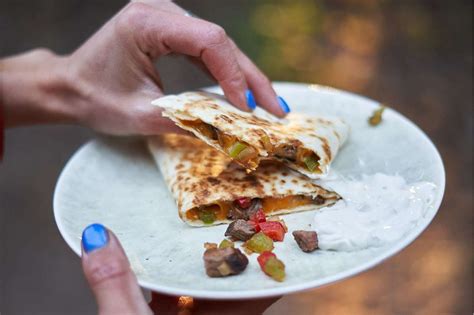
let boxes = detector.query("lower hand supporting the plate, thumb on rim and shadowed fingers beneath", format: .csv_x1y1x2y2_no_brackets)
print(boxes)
82,224,277,315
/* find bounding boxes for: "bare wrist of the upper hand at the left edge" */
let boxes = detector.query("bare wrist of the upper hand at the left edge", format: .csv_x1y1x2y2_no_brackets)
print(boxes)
0,49,77,127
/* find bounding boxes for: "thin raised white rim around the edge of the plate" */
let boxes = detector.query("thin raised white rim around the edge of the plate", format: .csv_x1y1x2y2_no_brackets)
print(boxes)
53,81,446,300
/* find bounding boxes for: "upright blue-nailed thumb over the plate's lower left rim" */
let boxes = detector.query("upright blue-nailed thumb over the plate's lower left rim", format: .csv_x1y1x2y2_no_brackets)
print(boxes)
82,224,152,315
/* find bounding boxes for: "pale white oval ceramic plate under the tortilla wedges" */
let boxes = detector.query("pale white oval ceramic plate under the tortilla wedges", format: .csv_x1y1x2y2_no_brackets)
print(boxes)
54,83,445,299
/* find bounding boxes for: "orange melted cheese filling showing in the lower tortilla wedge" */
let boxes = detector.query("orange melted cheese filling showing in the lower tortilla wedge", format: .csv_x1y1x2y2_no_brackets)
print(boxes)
186,195,336,221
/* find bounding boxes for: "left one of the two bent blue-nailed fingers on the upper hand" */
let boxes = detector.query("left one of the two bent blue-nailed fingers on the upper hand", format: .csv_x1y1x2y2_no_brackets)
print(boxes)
116,3,253,110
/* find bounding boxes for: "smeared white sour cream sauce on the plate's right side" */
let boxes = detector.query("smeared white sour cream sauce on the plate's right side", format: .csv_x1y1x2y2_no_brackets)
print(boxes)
314,173,436,251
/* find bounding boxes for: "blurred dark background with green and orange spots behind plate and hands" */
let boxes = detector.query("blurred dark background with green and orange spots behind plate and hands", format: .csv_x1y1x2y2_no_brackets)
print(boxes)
0,0,474,314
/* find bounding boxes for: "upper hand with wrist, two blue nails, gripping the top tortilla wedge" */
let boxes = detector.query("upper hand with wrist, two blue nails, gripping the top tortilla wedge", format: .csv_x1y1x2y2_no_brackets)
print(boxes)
0,0,289,135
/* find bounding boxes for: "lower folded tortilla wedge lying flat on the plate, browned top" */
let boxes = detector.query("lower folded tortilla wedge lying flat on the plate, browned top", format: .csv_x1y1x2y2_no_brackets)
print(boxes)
148,134,340,226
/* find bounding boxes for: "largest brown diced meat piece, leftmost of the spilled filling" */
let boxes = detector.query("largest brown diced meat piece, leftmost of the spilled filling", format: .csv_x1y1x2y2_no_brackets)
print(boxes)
203,247,249,277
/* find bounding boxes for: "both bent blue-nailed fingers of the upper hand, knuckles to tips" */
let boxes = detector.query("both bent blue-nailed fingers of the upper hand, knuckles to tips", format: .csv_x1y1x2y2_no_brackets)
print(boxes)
117,0,290,117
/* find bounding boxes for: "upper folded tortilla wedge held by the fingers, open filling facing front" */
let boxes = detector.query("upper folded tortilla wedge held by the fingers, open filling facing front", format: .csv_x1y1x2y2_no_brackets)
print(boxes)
152,92,349,179
